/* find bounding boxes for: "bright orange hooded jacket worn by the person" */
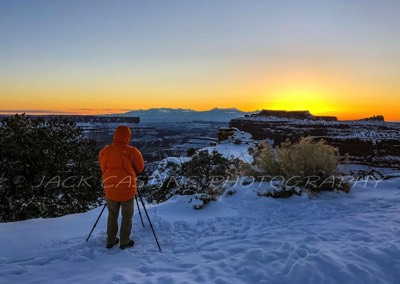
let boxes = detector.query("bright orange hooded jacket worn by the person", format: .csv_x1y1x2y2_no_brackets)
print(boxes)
99,126,144,201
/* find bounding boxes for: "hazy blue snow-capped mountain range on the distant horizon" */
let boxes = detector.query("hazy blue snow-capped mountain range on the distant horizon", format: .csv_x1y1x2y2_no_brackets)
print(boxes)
115,108,254,123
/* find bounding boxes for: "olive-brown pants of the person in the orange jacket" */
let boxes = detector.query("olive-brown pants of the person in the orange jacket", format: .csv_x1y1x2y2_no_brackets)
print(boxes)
107,198,133,245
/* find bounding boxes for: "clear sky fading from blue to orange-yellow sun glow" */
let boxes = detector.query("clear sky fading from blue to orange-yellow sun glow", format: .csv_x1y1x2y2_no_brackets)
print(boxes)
0,0,400,120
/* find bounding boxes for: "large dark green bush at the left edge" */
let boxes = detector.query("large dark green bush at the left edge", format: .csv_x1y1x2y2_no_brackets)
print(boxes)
0,115,103,222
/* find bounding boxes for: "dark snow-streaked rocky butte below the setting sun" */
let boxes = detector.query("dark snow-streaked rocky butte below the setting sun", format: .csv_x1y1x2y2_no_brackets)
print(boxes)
229,110,400,167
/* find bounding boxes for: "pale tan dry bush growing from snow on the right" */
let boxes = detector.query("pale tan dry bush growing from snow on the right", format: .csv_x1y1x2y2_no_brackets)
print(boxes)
241,137,348,194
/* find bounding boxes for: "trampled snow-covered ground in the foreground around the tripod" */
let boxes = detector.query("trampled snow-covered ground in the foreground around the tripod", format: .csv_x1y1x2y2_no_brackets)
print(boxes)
0,175,400,284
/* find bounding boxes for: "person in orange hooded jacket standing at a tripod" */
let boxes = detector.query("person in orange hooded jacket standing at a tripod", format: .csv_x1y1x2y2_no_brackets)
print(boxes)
99,126,144,249
